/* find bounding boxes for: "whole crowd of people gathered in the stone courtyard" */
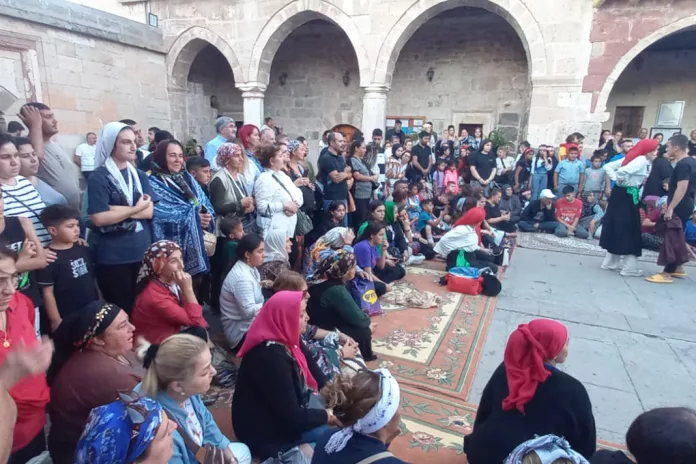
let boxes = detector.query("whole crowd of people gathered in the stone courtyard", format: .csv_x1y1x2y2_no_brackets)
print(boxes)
0,103,696,464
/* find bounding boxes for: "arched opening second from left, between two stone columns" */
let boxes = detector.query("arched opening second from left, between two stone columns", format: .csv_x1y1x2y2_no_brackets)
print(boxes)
265,19,363,155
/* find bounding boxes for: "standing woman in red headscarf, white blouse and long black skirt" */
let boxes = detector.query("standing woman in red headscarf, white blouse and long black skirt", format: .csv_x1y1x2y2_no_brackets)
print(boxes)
599,139,658,277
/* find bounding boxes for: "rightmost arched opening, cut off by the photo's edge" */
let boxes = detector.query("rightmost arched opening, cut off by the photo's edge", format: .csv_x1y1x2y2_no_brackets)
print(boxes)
604,26,696,138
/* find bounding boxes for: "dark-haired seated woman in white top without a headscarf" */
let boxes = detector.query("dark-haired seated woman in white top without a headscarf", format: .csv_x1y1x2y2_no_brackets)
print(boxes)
220,234,265,352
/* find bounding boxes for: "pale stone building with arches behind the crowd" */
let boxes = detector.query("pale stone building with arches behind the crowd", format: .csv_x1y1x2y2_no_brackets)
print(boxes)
0,0,696,158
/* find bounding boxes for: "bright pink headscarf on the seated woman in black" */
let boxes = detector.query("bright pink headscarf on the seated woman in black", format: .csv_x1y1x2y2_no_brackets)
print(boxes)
237,291,319,391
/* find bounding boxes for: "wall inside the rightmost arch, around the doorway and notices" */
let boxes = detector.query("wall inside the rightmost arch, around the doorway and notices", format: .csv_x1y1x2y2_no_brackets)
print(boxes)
604,50,696,135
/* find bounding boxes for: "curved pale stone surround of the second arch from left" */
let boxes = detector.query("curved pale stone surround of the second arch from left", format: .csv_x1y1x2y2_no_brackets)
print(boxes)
249,0,370,86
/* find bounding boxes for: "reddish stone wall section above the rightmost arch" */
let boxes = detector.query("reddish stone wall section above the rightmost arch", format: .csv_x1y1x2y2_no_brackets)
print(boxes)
583,0,696,111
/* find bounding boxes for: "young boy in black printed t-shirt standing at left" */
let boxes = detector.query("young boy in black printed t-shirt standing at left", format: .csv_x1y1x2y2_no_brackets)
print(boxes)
36,205,99,331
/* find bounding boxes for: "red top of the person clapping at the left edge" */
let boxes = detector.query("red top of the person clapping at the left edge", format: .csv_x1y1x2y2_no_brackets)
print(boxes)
0,292,50,453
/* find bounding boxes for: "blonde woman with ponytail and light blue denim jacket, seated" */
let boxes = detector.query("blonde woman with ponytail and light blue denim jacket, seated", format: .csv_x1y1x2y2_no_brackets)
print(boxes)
136,334,251,464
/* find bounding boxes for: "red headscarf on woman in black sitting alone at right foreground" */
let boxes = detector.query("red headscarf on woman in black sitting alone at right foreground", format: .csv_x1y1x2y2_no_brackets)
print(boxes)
503,319,568,414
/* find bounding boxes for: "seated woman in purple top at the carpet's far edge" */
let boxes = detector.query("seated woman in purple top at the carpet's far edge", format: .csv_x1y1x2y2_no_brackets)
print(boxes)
354,221,406,296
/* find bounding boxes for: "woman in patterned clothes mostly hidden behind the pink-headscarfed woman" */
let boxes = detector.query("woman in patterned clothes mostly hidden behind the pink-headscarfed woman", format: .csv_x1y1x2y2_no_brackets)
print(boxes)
273,271,365,379
